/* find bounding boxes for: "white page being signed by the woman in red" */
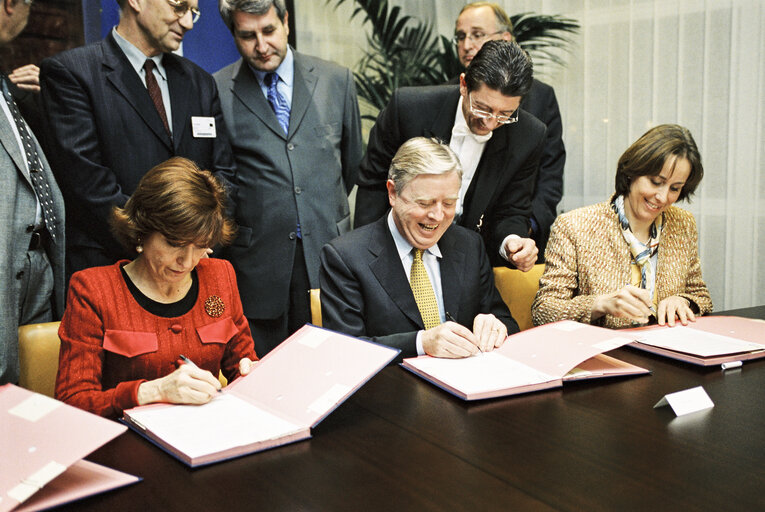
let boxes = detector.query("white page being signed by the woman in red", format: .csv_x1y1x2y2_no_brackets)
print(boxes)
130,394,301,457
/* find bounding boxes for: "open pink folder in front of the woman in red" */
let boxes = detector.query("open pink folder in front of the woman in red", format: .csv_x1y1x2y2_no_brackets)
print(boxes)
124,325,399,466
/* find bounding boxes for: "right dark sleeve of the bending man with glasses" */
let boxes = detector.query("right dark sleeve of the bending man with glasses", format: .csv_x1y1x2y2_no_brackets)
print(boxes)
486,120,545,256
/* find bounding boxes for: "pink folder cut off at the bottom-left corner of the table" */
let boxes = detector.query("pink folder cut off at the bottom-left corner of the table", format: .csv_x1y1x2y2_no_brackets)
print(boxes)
0,384,140,512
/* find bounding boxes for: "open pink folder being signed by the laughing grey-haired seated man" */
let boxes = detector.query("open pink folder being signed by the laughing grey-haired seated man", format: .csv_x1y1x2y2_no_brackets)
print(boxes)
401,320,649,400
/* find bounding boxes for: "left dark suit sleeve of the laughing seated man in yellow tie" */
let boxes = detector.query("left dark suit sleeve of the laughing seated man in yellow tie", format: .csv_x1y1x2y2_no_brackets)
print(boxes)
319,244,417,360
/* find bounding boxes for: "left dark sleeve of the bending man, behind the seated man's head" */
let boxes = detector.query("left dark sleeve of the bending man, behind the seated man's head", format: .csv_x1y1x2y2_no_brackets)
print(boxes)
354,90,404,227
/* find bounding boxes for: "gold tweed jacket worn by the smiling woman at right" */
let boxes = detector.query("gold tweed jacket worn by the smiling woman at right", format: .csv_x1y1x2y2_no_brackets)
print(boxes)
531,202,712,328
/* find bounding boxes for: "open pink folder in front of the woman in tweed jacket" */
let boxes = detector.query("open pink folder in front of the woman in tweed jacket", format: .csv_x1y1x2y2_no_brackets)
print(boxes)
622,316,765,366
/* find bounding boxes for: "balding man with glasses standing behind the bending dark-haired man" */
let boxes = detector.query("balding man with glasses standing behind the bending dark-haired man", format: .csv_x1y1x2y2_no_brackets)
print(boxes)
454,2,566,261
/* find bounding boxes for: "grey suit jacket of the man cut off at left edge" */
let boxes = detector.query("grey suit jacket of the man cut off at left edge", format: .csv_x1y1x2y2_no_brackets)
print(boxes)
0,106,64,384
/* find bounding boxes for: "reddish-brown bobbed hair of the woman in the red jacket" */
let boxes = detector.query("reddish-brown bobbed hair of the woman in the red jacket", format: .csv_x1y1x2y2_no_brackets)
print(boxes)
111,157,236,249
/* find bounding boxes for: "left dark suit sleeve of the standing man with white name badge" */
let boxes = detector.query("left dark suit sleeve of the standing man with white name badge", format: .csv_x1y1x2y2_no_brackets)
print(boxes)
40,58,128,252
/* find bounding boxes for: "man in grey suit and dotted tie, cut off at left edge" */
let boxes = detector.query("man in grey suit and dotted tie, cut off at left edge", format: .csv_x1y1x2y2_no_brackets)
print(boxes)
0,0,64,385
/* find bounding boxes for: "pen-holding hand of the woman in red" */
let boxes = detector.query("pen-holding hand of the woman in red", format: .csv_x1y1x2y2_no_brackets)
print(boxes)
138,364,221,405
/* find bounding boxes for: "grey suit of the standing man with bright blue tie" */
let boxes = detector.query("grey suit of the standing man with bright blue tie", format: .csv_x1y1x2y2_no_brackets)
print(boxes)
215,52,361,318
